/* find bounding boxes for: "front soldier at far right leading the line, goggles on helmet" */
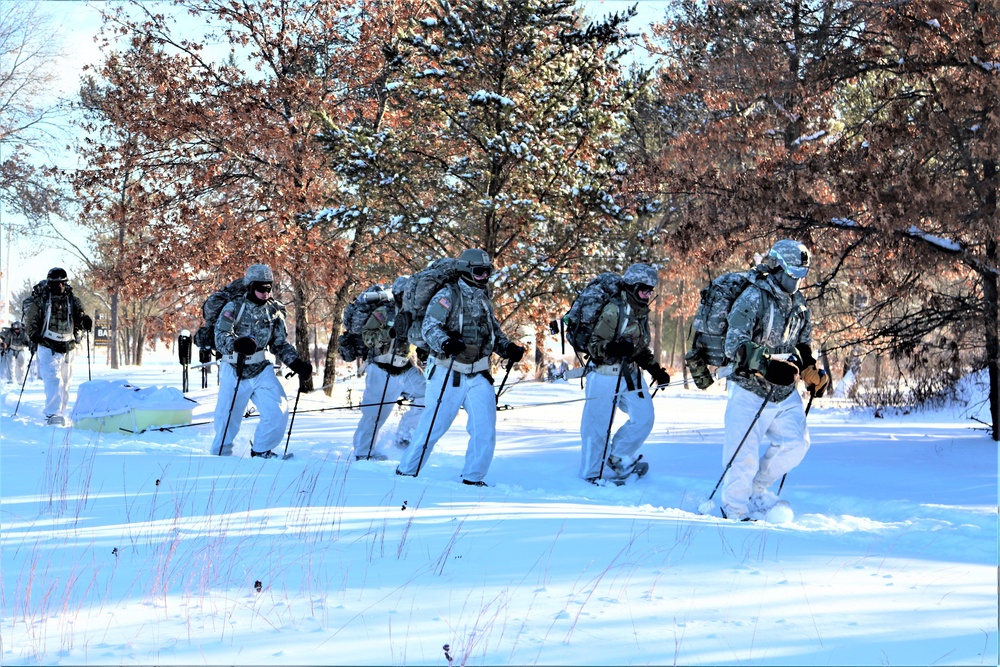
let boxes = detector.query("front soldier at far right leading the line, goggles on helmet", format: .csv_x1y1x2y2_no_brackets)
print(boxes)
722,239,829,521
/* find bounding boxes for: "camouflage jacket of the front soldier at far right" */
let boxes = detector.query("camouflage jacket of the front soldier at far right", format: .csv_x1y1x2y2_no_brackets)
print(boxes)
726,275,812,403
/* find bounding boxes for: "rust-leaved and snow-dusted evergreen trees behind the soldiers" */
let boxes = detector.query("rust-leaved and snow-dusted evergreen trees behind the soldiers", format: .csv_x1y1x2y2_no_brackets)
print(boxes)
0,0,1000,440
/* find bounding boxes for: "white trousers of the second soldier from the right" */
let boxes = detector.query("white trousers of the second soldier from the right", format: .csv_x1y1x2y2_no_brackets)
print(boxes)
580,373,654,479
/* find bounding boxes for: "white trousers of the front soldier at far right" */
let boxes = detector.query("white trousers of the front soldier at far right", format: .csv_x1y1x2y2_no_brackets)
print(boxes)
722,382,809,516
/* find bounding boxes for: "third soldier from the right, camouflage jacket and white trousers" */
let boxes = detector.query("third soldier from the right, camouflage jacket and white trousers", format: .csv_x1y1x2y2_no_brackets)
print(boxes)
396,249,524,486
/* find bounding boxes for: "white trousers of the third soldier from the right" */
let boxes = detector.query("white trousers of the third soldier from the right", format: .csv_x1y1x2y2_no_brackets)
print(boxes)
397,363,497,482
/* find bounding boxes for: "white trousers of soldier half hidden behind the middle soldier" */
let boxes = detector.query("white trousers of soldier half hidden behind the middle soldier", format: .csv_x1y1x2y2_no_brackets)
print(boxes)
354,364,426,456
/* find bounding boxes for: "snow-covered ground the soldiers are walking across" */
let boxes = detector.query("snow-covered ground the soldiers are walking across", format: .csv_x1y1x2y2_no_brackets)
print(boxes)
0,355,998,666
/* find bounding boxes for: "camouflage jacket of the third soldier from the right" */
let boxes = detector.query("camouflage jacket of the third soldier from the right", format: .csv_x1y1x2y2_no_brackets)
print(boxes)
420,280,510,364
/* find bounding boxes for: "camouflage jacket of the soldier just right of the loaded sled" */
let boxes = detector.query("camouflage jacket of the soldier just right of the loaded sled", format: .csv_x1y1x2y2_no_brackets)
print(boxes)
215,296,299,379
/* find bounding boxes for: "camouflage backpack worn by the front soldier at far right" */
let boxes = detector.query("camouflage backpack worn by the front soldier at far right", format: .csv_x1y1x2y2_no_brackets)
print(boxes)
684,268,761,389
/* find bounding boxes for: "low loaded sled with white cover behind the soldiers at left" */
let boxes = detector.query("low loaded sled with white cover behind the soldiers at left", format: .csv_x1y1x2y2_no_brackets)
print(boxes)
70,380,198,433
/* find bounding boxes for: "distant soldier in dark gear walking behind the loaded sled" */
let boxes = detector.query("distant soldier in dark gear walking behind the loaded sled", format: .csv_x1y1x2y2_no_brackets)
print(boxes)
24,267,94,426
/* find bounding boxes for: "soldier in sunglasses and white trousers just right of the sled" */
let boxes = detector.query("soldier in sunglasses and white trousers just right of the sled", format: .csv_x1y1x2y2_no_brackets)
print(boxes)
211,264,312,459
